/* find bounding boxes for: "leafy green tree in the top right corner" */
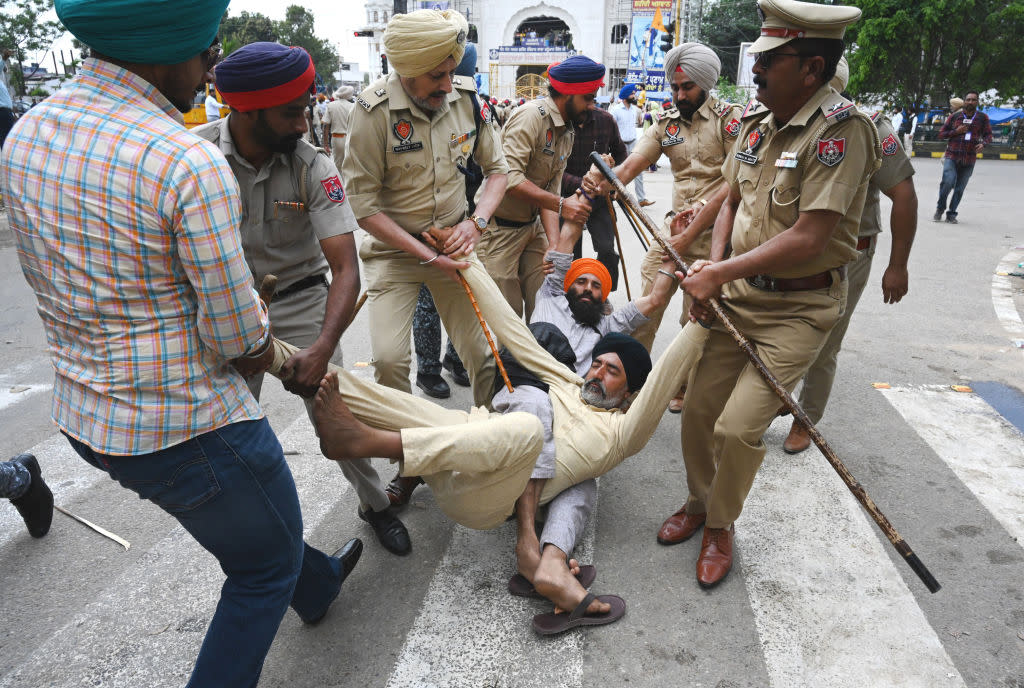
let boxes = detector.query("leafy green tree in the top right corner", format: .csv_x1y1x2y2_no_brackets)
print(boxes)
847,0,1024,105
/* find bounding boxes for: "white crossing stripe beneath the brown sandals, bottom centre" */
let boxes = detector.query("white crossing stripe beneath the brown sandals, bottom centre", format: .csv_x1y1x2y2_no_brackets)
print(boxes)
387,489,600,688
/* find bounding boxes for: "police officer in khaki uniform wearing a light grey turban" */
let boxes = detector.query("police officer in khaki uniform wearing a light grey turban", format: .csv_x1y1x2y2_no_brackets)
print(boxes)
584,43,740,351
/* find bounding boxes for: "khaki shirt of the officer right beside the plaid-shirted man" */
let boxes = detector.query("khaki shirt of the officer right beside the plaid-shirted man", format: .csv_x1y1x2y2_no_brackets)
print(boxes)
193,115,358,290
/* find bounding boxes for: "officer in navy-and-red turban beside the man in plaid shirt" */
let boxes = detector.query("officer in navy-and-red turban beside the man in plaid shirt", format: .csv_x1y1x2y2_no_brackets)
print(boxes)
195,43,411,554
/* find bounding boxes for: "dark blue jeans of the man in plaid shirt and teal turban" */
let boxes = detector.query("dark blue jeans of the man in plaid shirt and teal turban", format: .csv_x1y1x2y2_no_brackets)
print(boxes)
66,419,341,688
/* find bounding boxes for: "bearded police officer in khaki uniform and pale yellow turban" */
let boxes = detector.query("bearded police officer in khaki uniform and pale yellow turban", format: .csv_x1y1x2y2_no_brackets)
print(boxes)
343,10,508,405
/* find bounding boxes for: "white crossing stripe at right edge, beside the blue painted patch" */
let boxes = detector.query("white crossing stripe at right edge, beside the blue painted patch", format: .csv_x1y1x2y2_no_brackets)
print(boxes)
881,386,1024,547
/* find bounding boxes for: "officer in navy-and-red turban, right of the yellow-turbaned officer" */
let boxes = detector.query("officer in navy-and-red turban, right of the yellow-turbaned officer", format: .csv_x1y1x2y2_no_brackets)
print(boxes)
477,55,604,321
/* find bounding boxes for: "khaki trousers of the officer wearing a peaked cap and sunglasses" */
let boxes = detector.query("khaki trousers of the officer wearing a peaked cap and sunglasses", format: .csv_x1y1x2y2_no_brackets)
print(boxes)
682,270,847,528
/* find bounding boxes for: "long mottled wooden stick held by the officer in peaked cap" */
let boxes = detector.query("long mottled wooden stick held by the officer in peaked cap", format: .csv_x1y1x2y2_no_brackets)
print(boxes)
591,154,941,593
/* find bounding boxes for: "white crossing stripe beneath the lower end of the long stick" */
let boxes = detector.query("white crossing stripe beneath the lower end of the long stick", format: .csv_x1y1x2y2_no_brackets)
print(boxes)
736,419,965,688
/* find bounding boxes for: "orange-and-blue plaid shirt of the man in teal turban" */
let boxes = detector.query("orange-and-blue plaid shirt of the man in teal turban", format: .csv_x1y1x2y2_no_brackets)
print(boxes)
0,59,269,456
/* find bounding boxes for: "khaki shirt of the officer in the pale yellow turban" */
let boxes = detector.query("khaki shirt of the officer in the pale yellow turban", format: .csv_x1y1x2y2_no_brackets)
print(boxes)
344,72,508,234
